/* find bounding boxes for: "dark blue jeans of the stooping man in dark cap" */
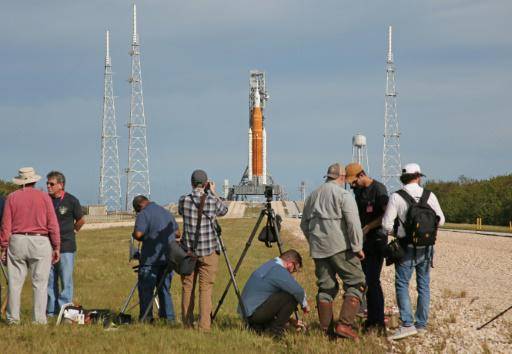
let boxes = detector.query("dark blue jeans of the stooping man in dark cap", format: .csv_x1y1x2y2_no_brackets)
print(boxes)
138,265,175,321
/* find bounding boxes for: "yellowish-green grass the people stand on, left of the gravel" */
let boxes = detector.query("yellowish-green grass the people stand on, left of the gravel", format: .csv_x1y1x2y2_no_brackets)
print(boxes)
0,219,389,353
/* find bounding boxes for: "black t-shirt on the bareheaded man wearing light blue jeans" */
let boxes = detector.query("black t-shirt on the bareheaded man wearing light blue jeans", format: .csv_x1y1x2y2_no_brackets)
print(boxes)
52,192,83,253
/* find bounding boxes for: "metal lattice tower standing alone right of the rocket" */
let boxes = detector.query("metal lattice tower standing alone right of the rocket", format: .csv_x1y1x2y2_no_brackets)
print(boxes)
382,26,402,193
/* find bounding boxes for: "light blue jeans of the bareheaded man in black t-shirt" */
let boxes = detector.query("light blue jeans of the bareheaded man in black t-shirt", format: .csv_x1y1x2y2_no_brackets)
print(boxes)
46,252,75,315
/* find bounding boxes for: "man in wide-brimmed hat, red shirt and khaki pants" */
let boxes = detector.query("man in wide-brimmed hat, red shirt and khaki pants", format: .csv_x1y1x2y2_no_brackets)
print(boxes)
0,167,60,324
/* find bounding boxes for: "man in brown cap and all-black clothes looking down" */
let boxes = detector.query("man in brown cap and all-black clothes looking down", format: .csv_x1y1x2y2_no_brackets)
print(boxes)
345,162,389,334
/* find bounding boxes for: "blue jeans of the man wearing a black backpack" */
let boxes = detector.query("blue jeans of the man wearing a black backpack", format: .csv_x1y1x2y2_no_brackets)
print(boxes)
395,247,434,328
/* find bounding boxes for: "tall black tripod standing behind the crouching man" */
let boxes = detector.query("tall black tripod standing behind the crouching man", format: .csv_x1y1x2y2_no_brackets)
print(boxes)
211,198,286,321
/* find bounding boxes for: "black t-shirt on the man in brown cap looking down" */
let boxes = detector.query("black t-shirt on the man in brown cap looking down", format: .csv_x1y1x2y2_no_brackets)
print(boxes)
354,180,389,252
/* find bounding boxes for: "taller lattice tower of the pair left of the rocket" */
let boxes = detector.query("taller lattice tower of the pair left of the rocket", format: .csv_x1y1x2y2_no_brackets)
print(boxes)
126,4,150,210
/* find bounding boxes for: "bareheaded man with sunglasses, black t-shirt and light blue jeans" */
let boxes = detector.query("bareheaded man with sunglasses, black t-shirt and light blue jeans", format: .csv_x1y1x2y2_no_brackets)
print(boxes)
46,171,85,316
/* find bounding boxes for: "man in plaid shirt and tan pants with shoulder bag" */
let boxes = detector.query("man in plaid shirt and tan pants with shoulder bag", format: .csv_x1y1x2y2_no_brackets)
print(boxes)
178,170,228,331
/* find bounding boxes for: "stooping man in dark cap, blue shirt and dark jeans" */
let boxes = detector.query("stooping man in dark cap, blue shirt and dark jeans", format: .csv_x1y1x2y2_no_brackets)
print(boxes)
132,195,178,322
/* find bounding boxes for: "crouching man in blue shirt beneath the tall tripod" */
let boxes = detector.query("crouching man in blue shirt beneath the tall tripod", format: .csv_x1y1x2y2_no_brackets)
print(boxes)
239,250,309,337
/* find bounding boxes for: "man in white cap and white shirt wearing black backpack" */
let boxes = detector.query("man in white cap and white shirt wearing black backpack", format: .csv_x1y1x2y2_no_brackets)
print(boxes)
382,163,444,340
